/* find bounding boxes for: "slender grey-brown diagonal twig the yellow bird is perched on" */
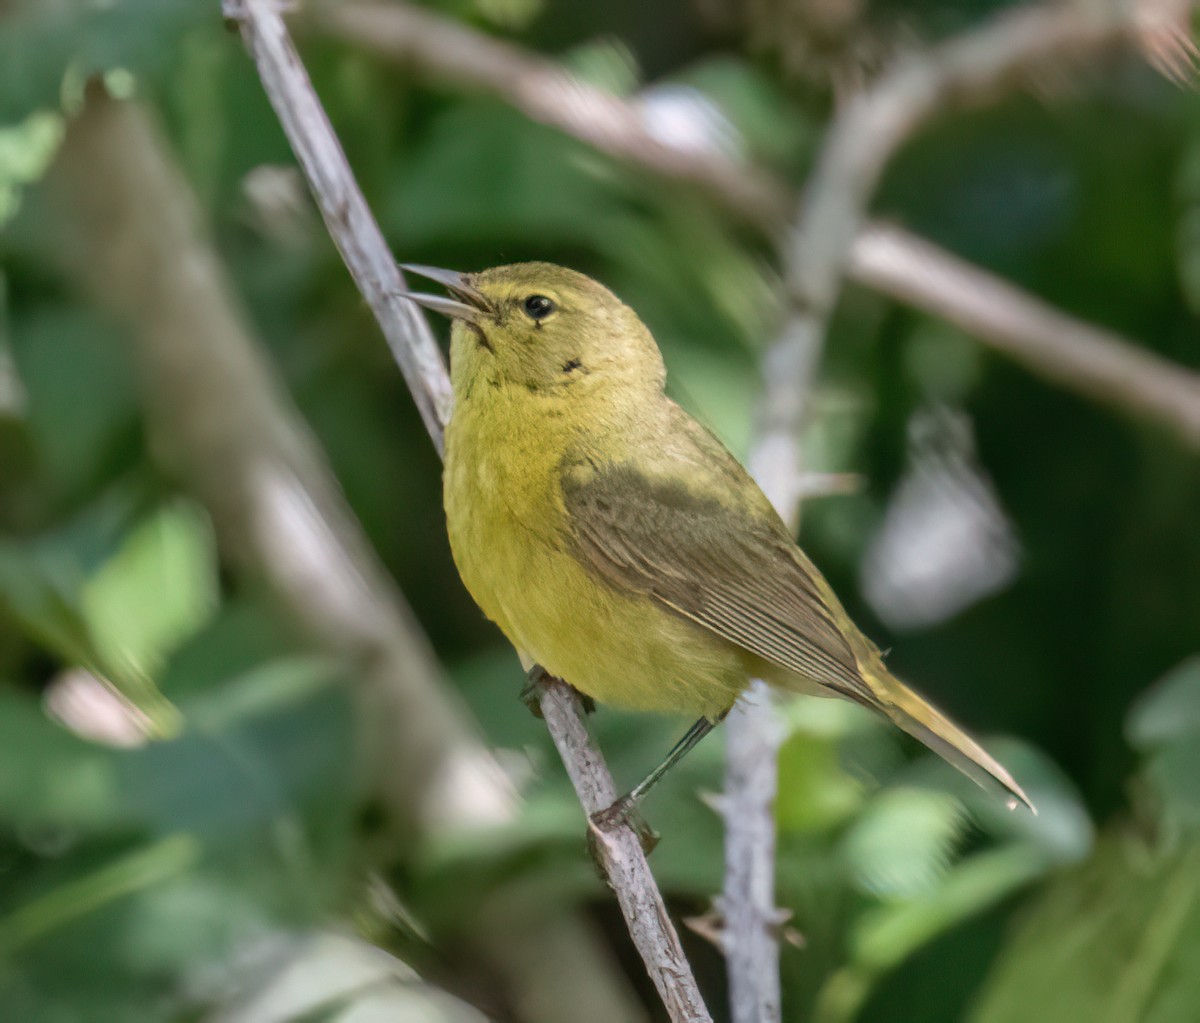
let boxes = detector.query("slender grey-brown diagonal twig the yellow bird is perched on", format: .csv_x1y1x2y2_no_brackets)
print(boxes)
226,0,709,1023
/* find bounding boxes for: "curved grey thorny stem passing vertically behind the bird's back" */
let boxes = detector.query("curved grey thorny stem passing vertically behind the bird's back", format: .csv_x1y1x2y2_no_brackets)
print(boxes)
721,12,1171,1023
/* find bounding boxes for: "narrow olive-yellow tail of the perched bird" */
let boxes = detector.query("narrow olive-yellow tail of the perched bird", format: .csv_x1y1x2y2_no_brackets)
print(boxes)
853,650,1038,813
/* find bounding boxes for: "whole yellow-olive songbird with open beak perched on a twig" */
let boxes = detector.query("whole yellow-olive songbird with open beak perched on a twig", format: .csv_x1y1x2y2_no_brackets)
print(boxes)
406,263,1032,816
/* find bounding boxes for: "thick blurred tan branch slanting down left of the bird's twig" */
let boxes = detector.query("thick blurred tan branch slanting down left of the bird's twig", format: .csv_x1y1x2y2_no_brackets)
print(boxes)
50,81,516,833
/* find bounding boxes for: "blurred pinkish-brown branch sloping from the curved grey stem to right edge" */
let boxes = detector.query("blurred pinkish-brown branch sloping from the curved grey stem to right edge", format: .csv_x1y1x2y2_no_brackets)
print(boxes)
851,226,1200,448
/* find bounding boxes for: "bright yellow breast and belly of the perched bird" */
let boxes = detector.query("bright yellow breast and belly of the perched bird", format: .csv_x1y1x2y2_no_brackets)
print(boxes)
445,396,748,717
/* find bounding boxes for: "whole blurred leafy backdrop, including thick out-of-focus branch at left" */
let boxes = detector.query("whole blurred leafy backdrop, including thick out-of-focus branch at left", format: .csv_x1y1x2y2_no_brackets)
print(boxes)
0,0,1200,1023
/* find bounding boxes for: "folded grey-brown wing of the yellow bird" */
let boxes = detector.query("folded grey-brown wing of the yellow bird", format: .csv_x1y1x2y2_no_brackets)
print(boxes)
563,456,874,702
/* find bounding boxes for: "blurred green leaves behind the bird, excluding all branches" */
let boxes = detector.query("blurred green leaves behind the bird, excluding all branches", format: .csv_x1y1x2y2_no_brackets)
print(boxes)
0,0,1200,1023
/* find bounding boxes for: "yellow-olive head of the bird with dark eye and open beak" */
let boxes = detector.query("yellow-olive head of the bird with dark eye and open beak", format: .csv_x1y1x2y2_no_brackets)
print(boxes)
404,263,664,400
